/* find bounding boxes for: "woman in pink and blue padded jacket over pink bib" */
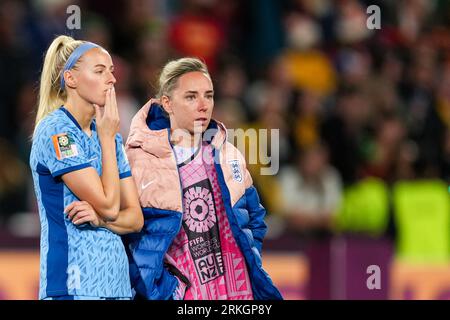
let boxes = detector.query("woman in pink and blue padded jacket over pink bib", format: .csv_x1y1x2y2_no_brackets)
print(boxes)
124,58,282,300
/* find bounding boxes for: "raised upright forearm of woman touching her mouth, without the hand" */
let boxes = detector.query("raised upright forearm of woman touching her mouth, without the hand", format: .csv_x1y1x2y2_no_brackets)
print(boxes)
98,137,120,220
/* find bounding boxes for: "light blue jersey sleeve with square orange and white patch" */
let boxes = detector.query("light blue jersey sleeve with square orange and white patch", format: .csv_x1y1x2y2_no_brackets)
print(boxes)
39,125,91,177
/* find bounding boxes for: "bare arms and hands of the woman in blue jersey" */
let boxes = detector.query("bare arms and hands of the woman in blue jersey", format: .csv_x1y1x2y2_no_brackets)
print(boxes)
61,86,144,234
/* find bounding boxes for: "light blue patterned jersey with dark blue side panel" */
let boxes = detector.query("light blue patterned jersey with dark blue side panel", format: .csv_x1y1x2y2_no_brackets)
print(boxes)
30,107,131,299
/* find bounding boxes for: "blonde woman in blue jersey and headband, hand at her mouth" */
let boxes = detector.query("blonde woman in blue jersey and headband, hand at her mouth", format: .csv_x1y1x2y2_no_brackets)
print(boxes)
30,36,143,300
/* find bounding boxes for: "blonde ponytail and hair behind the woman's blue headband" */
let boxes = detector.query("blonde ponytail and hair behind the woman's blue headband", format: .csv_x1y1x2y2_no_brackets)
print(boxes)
35,36,84,135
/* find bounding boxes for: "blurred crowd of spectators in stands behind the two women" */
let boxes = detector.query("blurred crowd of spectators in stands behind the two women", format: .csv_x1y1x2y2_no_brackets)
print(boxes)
0,0,450,264
